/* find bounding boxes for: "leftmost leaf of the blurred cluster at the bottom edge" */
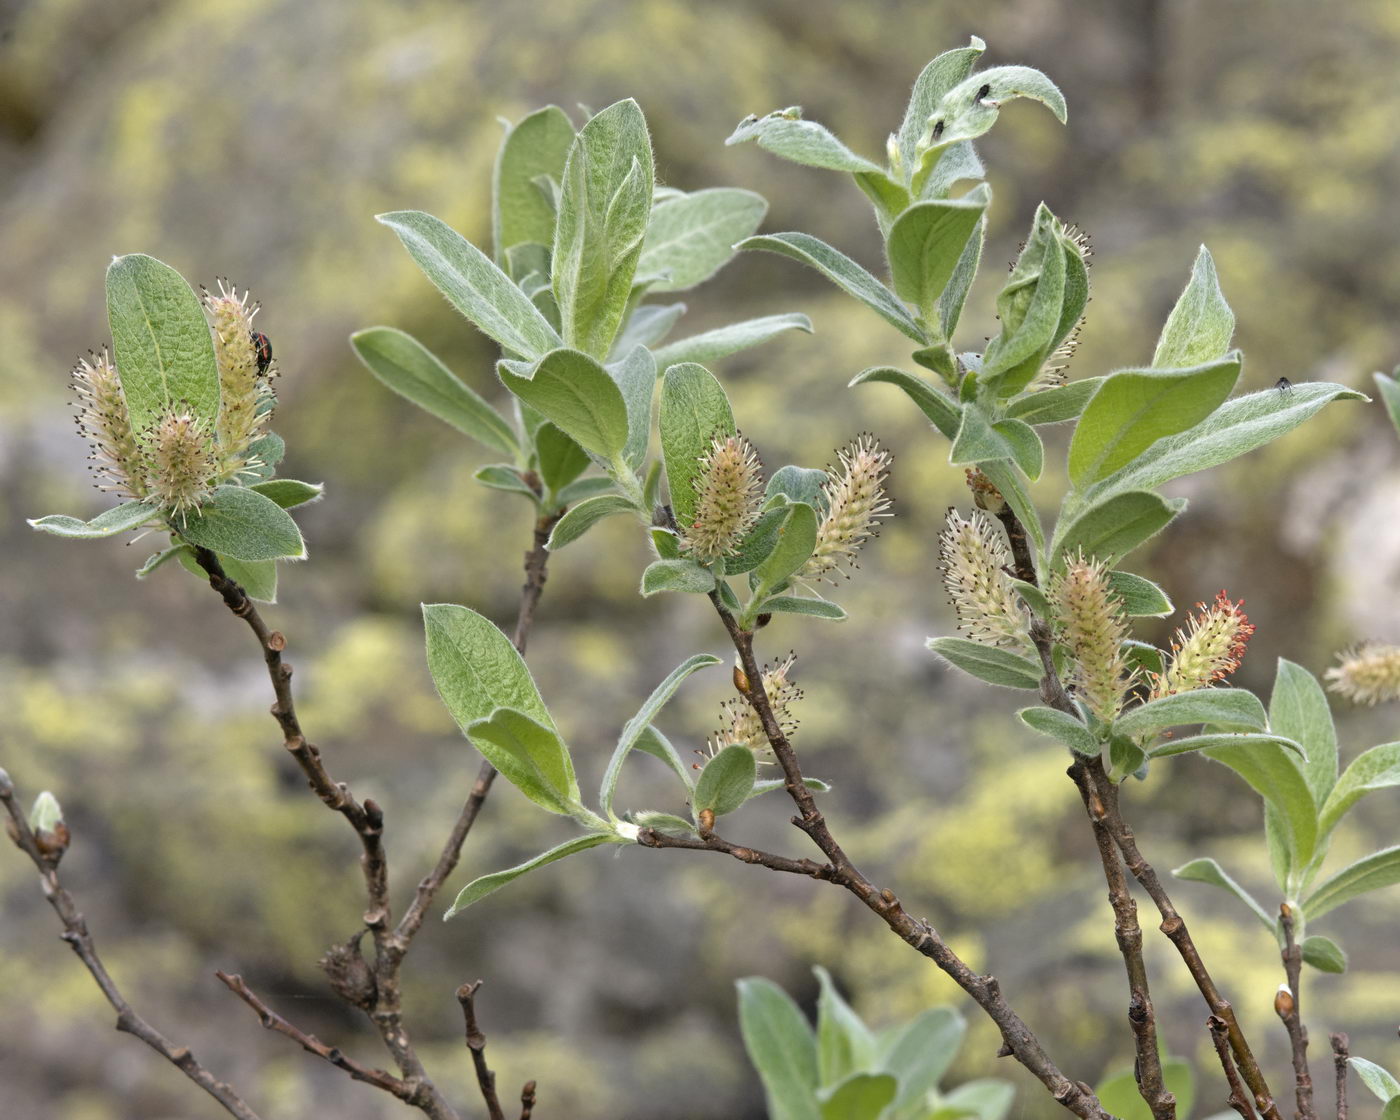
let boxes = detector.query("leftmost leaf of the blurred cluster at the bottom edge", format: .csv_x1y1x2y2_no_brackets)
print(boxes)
738,968,822,1120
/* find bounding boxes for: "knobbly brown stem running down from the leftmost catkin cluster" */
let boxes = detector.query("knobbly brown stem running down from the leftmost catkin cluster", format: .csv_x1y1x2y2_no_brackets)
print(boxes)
195,547,459,1120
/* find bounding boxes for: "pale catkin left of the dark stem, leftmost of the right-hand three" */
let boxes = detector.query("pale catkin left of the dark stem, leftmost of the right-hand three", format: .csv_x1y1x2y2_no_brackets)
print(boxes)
938,508,1030,648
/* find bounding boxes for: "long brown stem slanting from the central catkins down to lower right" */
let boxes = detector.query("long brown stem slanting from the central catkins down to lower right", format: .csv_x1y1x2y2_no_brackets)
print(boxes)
697,591,1109,1120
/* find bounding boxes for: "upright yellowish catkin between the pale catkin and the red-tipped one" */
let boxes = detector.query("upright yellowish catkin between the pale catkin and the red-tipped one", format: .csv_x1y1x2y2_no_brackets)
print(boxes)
1050,553,1138,724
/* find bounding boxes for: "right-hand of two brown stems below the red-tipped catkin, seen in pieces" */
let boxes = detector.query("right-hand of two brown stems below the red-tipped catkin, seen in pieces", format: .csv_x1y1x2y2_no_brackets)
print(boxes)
998,507,1281,1120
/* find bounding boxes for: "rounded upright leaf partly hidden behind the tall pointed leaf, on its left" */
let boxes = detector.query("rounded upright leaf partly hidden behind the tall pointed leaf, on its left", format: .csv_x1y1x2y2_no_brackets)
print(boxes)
491,105,574,260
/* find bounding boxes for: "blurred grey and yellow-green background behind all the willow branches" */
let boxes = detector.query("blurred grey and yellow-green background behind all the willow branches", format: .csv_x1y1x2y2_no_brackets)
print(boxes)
0,0,1400,1120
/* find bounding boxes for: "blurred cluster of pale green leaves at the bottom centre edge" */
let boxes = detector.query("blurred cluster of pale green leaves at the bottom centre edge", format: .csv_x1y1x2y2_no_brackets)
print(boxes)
738,966,1015,1120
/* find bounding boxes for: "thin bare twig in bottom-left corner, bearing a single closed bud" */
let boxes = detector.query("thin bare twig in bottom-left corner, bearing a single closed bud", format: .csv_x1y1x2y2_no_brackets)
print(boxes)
0,770,259,1120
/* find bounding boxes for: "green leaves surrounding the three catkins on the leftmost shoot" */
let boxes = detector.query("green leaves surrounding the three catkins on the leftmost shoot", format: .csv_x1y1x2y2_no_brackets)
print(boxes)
29,253,322,602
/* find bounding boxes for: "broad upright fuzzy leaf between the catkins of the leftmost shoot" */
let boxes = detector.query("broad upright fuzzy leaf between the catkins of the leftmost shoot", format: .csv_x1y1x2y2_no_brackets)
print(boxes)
106,253,218,433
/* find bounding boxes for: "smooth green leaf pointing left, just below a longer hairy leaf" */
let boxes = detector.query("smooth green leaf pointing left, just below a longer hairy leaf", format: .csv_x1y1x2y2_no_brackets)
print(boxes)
350,326,518,455
